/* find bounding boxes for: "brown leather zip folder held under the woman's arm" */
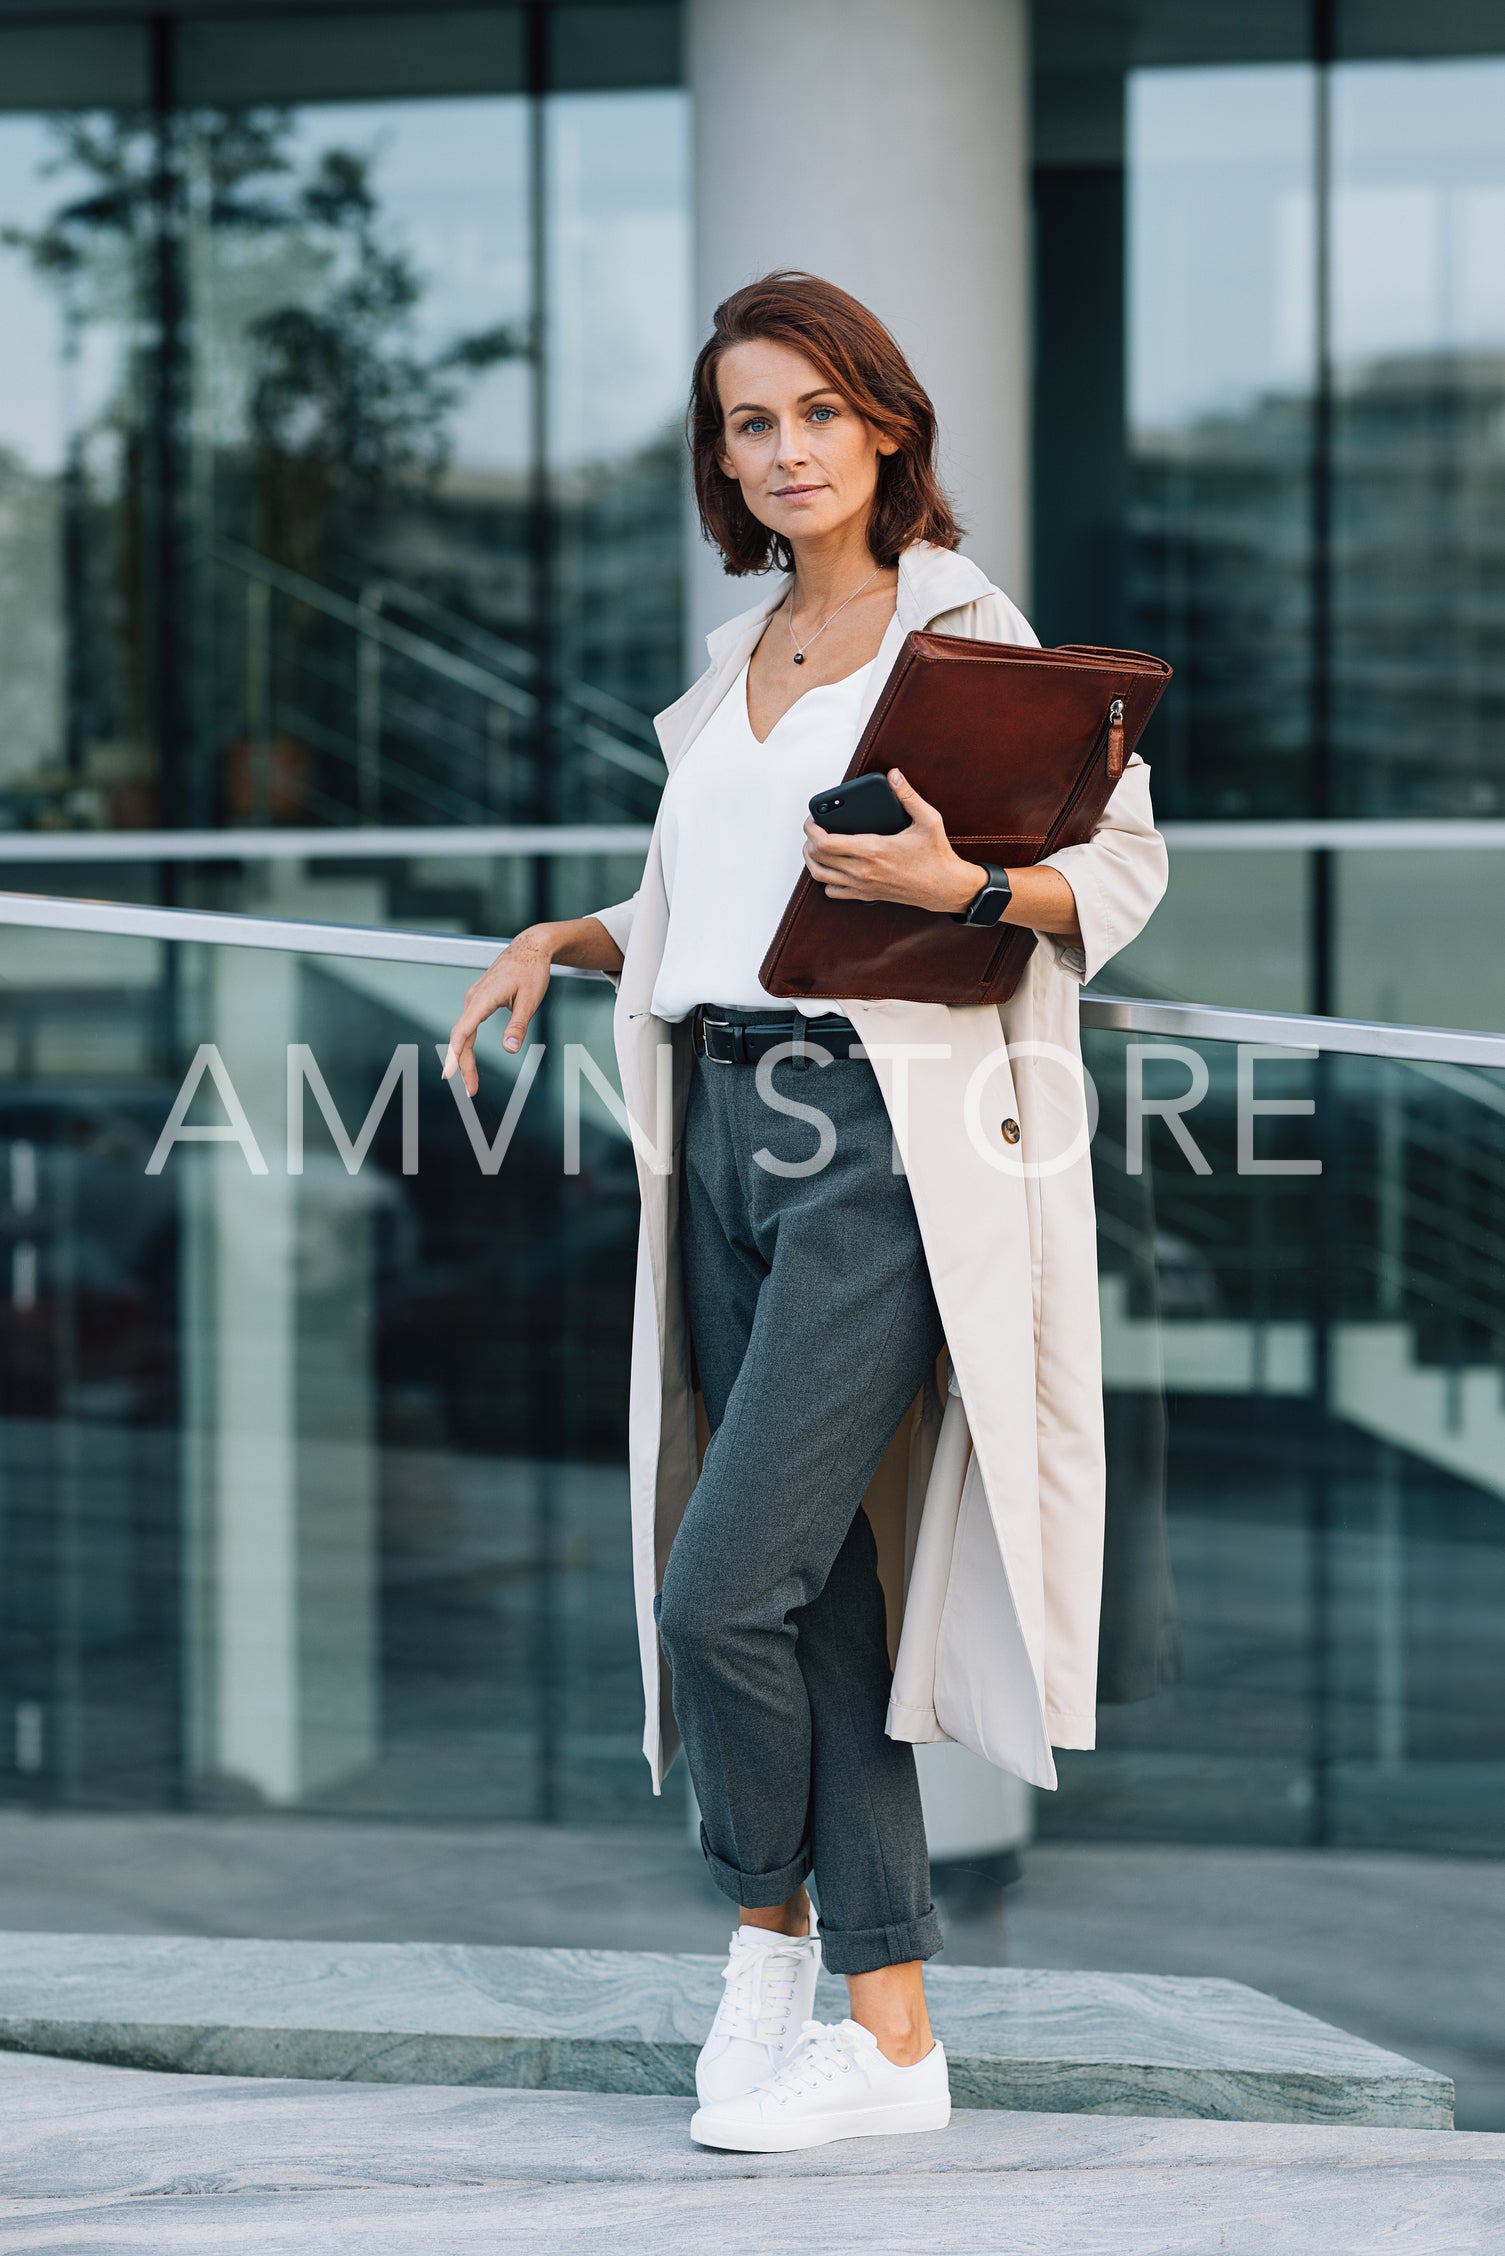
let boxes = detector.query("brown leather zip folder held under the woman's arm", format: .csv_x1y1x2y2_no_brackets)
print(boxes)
758,634,1171,1004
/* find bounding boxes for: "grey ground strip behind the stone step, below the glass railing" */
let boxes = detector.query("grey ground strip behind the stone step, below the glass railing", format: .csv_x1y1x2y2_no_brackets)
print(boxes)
0,1812,1505,2130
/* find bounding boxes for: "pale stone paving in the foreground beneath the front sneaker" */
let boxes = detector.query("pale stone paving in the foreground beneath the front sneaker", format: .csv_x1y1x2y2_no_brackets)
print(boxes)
0,2057,1505,2256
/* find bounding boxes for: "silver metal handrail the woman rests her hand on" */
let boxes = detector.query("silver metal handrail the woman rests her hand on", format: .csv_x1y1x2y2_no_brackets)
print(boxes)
0,884,1505,1072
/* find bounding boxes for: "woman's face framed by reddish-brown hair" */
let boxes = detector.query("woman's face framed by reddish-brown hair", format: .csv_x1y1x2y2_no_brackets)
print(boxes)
715,338,898,557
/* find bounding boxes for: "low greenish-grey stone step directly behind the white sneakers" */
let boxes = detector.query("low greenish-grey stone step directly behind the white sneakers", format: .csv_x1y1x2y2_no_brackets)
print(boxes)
0,1933,1453,2127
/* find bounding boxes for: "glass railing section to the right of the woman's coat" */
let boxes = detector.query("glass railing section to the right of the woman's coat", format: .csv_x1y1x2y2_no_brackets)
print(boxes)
1078,1033,1505,1852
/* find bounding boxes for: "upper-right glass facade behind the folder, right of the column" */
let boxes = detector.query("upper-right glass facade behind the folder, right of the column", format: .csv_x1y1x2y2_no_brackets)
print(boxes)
1036,0,1505,817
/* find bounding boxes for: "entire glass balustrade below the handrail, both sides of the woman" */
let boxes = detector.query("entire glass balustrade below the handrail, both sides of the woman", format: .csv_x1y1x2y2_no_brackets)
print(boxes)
0,905,1505,1876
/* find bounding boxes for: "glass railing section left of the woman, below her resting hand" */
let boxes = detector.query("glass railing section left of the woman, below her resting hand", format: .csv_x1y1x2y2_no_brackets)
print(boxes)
0,927,649,1823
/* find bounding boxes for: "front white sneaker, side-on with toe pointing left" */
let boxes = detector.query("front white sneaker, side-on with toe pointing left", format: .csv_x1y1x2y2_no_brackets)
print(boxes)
690,2021,952,2154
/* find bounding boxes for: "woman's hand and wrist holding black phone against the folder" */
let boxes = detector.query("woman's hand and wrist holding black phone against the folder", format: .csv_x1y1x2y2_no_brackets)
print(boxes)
806,767,1081,945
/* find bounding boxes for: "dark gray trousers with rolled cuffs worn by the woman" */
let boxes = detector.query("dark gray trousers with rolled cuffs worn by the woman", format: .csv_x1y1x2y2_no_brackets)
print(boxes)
659,1037,941,1974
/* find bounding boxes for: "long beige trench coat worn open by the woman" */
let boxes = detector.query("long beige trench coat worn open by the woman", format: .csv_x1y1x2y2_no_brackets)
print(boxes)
596,546,1167,1791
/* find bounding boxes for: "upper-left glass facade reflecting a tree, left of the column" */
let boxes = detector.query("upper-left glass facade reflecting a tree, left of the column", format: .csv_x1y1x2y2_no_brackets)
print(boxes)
0,5,688,830
